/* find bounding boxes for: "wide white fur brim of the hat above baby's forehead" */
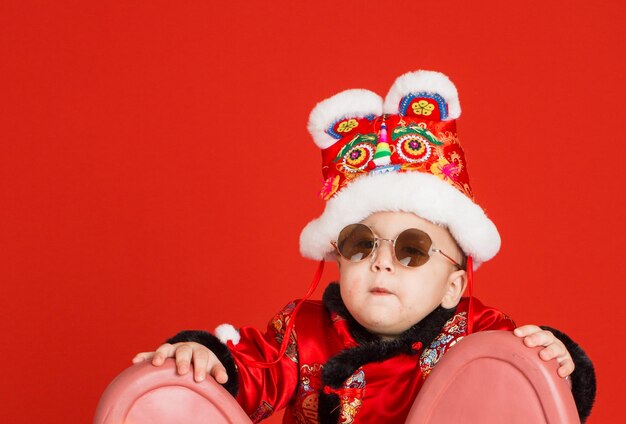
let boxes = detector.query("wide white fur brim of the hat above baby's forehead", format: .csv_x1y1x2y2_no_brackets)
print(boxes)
300,172,500,268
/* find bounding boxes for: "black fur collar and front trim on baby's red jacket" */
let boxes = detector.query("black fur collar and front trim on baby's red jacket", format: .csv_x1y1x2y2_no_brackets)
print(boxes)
318,283,455,424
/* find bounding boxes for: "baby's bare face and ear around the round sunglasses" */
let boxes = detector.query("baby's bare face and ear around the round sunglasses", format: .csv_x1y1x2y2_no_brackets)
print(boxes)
337,212,465,339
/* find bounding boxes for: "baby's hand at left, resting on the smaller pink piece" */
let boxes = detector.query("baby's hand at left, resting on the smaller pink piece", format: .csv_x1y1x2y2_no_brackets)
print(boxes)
133,342,228,384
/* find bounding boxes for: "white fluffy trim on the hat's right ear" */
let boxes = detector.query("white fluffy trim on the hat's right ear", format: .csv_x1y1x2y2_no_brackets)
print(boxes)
383,71,461,121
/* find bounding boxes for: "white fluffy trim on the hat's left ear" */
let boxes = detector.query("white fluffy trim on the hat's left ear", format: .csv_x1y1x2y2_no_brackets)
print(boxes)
308,89,383,149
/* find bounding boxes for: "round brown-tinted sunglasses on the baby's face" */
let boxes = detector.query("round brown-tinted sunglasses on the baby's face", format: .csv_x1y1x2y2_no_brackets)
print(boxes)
332,224,465,269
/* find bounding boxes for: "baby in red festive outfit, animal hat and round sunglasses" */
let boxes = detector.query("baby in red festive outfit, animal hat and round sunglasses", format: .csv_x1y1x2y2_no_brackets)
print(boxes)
133,71,595,423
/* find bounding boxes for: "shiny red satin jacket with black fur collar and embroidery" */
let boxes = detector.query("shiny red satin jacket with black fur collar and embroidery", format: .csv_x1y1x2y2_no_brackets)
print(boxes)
224,284,515,424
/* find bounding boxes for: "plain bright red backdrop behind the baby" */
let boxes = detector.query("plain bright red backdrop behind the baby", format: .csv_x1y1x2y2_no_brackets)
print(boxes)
0,0,626,423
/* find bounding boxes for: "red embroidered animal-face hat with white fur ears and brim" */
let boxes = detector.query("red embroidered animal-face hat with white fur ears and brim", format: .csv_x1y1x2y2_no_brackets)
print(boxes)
300,71,500,268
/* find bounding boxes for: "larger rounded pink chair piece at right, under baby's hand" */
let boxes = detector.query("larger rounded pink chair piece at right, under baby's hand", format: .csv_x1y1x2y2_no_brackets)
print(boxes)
407,331,580,424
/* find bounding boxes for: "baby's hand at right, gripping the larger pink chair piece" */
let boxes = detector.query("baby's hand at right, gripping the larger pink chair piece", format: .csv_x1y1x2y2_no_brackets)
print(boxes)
513,325,574,377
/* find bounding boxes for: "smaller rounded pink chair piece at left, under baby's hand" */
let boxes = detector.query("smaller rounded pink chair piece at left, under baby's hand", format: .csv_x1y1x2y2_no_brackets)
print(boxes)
94,359,252,424
